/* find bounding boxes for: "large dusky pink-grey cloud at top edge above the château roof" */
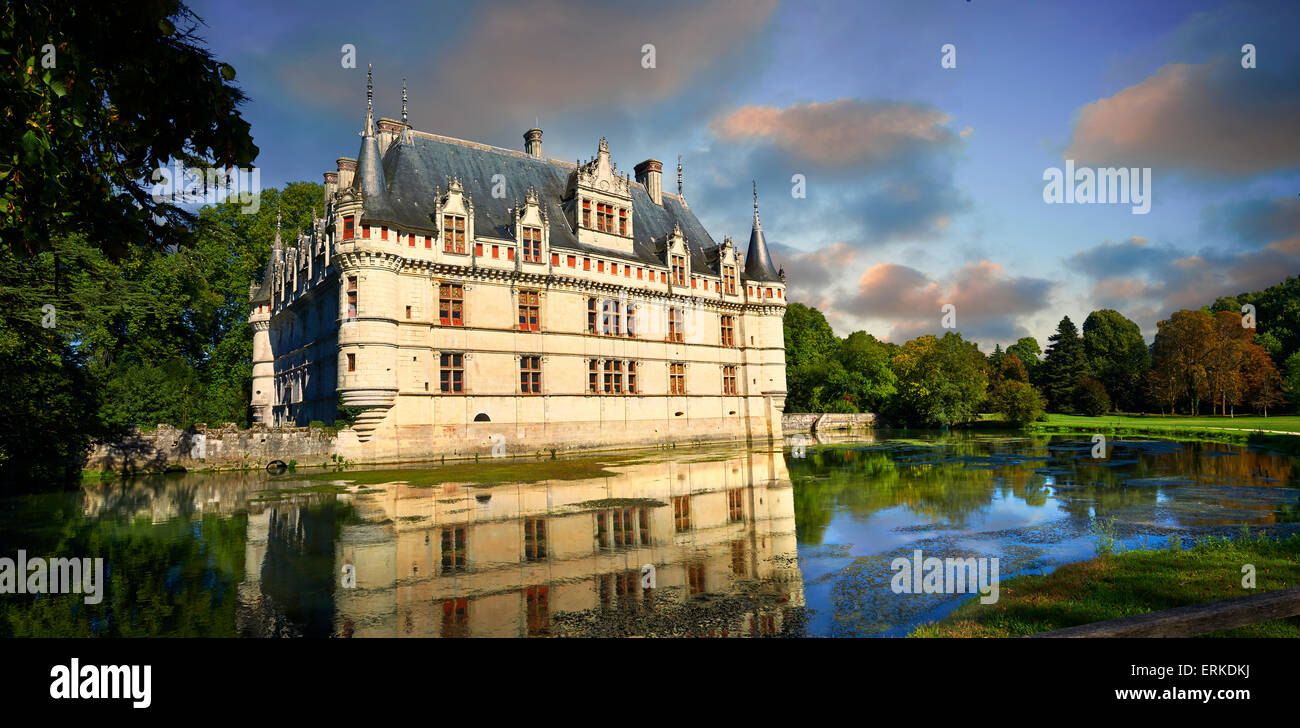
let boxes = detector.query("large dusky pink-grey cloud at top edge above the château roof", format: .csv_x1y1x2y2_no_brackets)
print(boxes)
421,0,776,131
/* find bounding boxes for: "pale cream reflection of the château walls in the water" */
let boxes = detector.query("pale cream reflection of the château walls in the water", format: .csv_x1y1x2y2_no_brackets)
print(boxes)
322,451,803,637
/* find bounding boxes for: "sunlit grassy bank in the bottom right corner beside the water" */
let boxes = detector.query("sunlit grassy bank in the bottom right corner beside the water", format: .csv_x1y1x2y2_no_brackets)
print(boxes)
911,534,1300,637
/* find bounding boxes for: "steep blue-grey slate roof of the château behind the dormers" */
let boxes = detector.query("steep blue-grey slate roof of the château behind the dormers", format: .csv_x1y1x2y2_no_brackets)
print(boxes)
354,130,738,276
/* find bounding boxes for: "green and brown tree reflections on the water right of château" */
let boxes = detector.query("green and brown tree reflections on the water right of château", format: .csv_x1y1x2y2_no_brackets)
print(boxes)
787,434,1300,543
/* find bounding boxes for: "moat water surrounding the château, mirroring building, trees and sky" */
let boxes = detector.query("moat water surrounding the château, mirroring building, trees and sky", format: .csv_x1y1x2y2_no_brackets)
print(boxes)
0,433,1300,637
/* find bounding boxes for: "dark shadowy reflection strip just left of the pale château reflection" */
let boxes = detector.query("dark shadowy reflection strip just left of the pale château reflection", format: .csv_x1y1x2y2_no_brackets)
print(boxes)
255,498,351,637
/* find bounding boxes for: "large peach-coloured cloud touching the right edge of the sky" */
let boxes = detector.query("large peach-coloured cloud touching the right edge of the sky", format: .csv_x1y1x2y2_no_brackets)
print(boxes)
1065,57,1300,177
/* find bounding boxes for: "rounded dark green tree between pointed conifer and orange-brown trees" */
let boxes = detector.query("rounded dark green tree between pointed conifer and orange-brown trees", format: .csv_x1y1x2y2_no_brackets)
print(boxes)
1083,308,1151,411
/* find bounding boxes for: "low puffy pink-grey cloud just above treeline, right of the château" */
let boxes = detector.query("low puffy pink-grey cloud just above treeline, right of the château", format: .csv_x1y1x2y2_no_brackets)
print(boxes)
852,260,1053,343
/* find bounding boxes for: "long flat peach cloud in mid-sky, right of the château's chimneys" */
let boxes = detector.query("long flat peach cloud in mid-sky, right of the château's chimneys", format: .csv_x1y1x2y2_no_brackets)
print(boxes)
710,99,969,170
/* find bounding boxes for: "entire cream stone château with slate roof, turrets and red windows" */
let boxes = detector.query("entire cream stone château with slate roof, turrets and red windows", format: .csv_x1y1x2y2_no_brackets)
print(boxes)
250,74,785,462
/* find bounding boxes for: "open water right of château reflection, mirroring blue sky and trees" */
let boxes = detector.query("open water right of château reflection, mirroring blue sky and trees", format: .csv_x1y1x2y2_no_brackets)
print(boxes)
792,436,1300,636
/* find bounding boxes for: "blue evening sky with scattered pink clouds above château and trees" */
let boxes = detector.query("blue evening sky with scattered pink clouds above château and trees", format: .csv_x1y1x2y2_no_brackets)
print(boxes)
191,0,1300,351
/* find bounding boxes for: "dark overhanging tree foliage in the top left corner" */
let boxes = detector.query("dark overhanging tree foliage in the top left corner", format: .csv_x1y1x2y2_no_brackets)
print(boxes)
0,0,257,257
